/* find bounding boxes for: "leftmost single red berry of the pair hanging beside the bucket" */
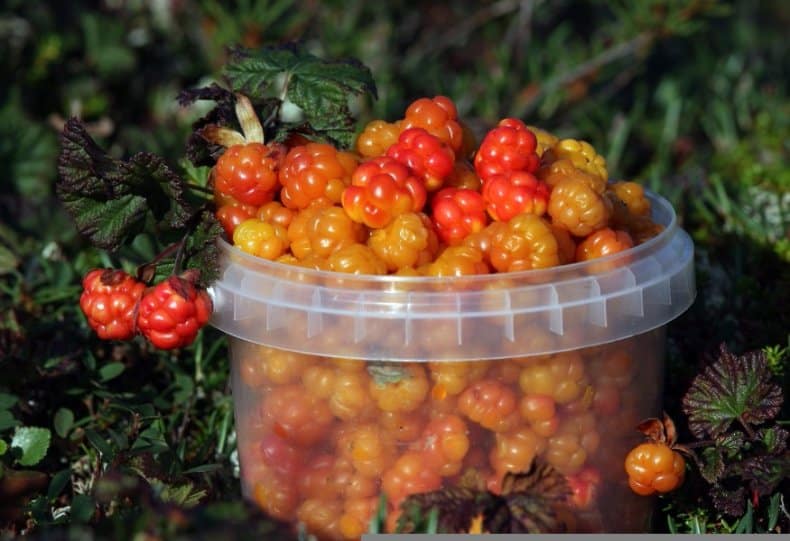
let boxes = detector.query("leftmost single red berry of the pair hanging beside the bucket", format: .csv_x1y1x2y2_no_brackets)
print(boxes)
80,269,145,340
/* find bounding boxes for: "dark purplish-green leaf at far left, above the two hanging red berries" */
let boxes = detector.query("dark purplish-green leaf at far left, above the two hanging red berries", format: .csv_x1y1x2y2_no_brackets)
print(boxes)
57,118,192,251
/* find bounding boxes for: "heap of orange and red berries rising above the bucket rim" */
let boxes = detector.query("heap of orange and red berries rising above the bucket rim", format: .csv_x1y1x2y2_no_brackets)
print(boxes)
213,95,662,277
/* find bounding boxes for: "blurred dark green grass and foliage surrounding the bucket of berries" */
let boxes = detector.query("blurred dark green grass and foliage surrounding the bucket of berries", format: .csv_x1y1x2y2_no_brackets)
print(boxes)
0,0,790,538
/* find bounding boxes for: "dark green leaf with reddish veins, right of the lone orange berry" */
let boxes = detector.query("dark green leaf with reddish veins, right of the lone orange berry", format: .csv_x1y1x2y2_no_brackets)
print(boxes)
683,344,783,439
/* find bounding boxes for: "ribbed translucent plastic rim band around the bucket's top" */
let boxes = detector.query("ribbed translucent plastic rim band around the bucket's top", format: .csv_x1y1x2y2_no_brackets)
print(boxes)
210,194,696,361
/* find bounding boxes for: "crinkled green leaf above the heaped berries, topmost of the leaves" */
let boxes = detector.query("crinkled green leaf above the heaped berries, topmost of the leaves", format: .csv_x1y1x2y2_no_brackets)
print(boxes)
224,43,377,147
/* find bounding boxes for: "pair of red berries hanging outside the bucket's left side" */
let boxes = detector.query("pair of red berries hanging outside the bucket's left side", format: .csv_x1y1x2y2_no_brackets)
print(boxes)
80,269,212,349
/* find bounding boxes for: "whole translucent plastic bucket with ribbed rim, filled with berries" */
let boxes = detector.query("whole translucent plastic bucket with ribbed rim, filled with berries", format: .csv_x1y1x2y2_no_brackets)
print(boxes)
211,190,695,539
